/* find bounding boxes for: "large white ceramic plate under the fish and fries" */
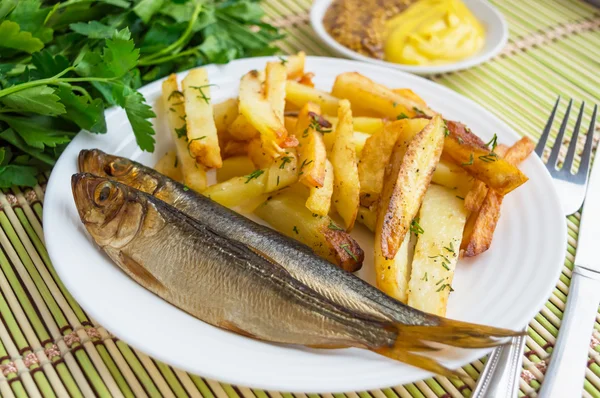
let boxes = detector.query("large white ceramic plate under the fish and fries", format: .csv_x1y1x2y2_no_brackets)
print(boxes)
44,57,566,392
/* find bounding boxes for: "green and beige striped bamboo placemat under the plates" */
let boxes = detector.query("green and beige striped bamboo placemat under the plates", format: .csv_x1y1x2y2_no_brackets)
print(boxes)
0,0,600,398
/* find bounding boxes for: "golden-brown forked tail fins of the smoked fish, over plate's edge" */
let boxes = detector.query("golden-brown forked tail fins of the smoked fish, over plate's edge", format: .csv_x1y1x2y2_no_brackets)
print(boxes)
371,318,524,377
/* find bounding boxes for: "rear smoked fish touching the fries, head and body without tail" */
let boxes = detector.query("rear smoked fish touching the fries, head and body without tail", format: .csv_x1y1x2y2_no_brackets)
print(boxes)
78,149,439,325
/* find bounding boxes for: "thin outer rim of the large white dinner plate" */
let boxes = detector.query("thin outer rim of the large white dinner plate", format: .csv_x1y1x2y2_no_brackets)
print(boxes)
43,56,567,393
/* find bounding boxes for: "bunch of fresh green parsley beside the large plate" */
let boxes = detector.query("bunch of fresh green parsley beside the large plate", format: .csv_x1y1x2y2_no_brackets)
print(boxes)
0,0,283,188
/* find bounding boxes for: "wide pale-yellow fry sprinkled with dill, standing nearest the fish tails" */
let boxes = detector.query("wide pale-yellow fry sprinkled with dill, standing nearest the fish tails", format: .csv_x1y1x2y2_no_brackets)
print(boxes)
408,184,467,316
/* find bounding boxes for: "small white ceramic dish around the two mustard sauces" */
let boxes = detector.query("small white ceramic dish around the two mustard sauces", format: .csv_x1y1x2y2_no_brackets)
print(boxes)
310,0,508,75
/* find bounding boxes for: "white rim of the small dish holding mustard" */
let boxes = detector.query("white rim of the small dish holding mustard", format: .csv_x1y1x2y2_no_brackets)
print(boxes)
310,0,509,75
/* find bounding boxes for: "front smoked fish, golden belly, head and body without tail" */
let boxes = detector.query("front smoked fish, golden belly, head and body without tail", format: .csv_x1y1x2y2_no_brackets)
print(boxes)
72,174,398,349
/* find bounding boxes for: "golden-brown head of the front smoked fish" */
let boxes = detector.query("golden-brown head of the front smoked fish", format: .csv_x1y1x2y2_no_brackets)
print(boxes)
71,173,146,248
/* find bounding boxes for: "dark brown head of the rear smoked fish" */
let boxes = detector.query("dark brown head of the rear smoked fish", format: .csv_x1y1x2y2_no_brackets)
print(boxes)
78,149,159,194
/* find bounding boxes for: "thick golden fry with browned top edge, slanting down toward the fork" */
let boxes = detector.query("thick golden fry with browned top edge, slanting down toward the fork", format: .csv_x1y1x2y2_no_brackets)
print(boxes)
444,122,527,195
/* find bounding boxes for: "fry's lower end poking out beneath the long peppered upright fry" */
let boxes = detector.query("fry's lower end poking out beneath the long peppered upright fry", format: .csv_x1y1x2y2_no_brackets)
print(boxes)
373,233,412,304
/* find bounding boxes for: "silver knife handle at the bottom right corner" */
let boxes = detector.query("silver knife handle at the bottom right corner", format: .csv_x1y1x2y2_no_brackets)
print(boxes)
539,266,600,398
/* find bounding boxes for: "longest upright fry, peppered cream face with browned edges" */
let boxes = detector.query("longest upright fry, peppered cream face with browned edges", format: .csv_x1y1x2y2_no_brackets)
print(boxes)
376,115,444,259
